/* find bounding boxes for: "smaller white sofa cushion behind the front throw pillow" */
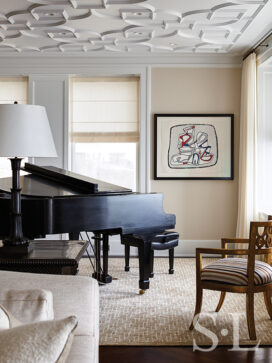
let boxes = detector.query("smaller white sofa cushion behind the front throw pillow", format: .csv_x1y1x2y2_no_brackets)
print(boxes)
0,289,54,323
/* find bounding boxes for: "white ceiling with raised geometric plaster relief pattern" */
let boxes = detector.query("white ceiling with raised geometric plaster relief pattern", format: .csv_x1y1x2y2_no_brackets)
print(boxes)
0,0,272,56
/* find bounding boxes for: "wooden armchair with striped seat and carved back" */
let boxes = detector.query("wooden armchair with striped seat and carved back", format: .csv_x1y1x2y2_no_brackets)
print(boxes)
190,221,272,340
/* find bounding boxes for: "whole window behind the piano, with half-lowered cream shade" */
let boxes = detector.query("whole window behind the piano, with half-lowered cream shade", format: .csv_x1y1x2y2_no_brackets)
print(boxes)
70,77,139,191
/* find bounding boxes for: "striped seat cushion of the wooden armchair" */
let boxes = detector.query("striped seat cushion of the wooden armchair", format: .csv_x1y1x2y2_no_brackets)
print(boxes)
201,258,272,285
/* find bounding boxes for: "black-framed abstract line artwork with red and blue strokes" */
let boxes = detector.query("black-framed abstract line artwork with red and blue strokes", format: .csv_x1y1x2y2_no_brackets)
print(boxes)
154,114,234,180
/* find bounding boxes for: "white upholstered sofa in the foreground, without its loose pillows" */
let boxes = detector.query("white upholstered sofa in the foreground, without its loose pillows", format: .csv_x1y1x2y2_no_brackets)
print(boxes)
0,271,99,363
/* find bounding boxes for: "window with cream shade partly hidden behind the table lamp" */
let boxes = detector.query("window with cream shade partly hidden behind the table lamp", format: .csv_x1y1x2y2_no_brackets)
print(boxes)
0,77,28,178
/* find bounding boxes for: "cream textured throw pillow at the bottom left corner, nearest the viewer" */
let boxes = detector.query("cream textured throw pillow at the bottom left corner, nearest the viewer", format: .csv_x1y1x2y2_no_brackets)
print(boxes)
0,316,77,363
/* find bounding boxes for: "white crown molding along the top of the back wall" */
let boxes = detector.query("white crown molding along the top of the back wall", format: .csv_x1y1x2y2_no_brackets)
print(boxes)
0,54,242,75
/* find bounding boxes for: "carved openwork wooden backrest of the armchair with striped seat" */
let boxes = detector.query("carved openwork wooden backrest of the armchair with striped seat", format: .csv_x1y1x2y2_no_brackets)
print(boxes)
248,220,272,285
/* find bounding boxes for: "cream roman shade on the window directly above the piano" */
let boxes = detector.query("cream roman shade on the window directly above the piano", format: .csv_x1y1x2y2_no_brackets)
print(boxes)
70,77,139,143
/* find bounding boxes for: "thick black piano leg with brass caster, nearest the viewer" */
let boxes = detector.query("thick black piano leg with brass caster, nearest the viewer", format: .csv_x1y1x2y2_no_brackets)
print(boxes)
138,238,152,295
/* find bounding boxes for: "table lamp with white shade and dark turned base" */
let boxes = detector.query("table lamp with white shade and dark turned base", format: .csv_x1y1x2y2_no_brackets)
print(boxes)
0,103,57,257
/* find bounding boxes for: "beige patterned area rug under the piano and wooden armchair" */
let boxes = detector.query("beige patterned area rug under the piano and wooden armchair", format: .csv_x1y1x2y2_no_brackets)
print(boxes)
77,258,272,346
